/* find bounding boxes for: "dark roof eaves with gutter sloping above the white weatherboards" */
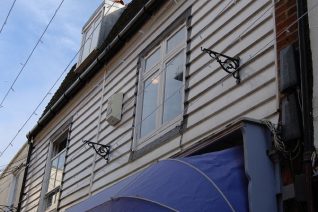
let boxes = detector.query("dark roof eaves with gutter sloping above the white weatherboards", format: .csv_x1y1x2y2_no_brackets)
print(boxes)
27,0,167,140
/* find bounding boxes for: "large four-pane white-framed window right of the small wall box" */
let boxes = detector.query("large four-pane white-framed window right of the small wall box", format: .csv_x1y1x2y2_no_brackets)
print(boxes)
136,25,187,142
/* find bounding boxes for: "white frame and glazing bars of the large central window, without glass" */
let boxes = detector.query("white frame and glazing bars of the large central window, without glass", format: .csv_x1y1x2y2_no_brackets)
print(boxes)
133,23,187,150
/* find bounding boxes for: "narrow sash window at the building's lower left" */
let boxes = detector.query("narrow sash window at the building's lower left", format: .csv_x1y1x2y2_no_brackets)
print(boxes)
45,135,67,211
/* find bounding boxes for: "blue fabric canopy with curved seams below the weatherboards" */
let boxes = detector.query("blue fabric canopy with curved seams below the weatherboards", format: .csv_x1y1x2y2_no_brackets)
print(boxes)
67,147,248,212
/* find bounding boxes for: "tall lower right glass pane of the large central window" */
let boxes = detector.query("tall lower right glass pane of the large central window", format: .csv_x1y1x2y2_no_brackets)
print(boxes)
163,52,184,122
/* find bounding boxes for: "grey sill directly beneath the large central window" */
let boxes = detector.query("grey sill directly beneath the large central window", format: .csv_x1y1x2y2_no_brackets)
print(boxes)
129,120,183,161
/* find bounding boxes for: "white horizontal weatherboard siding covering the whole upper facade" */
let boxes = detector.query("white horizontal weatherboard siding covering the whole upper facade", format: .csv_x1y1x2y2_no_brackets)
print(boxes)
20,0,278,211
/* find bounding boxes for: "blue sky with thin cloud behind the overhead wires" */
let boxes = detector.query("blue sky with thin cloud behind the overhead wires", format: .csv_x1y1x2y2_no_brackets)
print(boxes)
0,0,130,170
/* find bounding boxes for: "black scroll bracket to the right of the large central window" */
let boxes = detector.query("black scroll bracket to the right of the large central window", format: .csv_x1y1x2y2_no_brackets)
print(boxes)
201,47,241,84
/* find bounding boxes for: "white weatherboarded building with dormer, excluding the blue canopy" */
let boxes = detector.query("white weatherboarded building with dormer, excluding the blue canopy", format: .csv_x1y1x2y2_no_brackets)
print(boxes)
19,0,318,211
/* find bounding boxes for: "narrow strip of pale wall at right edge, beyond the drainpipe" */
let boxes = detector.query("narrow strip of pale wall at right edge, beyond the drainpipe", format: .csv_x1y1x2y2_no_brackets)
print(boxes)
307,0,318,148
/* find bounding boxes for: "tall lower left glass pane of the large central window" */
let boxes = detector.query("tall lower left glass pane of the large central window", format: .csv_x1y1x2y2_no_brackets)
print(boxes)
140,76,160,137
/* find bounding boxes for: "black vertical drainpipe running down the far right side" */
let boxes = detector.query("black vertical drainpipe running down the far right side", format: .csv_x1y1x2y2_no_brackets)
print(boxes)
297,0,315,212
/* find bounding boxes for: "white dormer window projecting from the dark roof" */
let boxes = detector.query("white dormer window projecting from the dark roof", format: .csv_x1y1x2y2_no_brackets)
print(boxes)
78,0,125,64
